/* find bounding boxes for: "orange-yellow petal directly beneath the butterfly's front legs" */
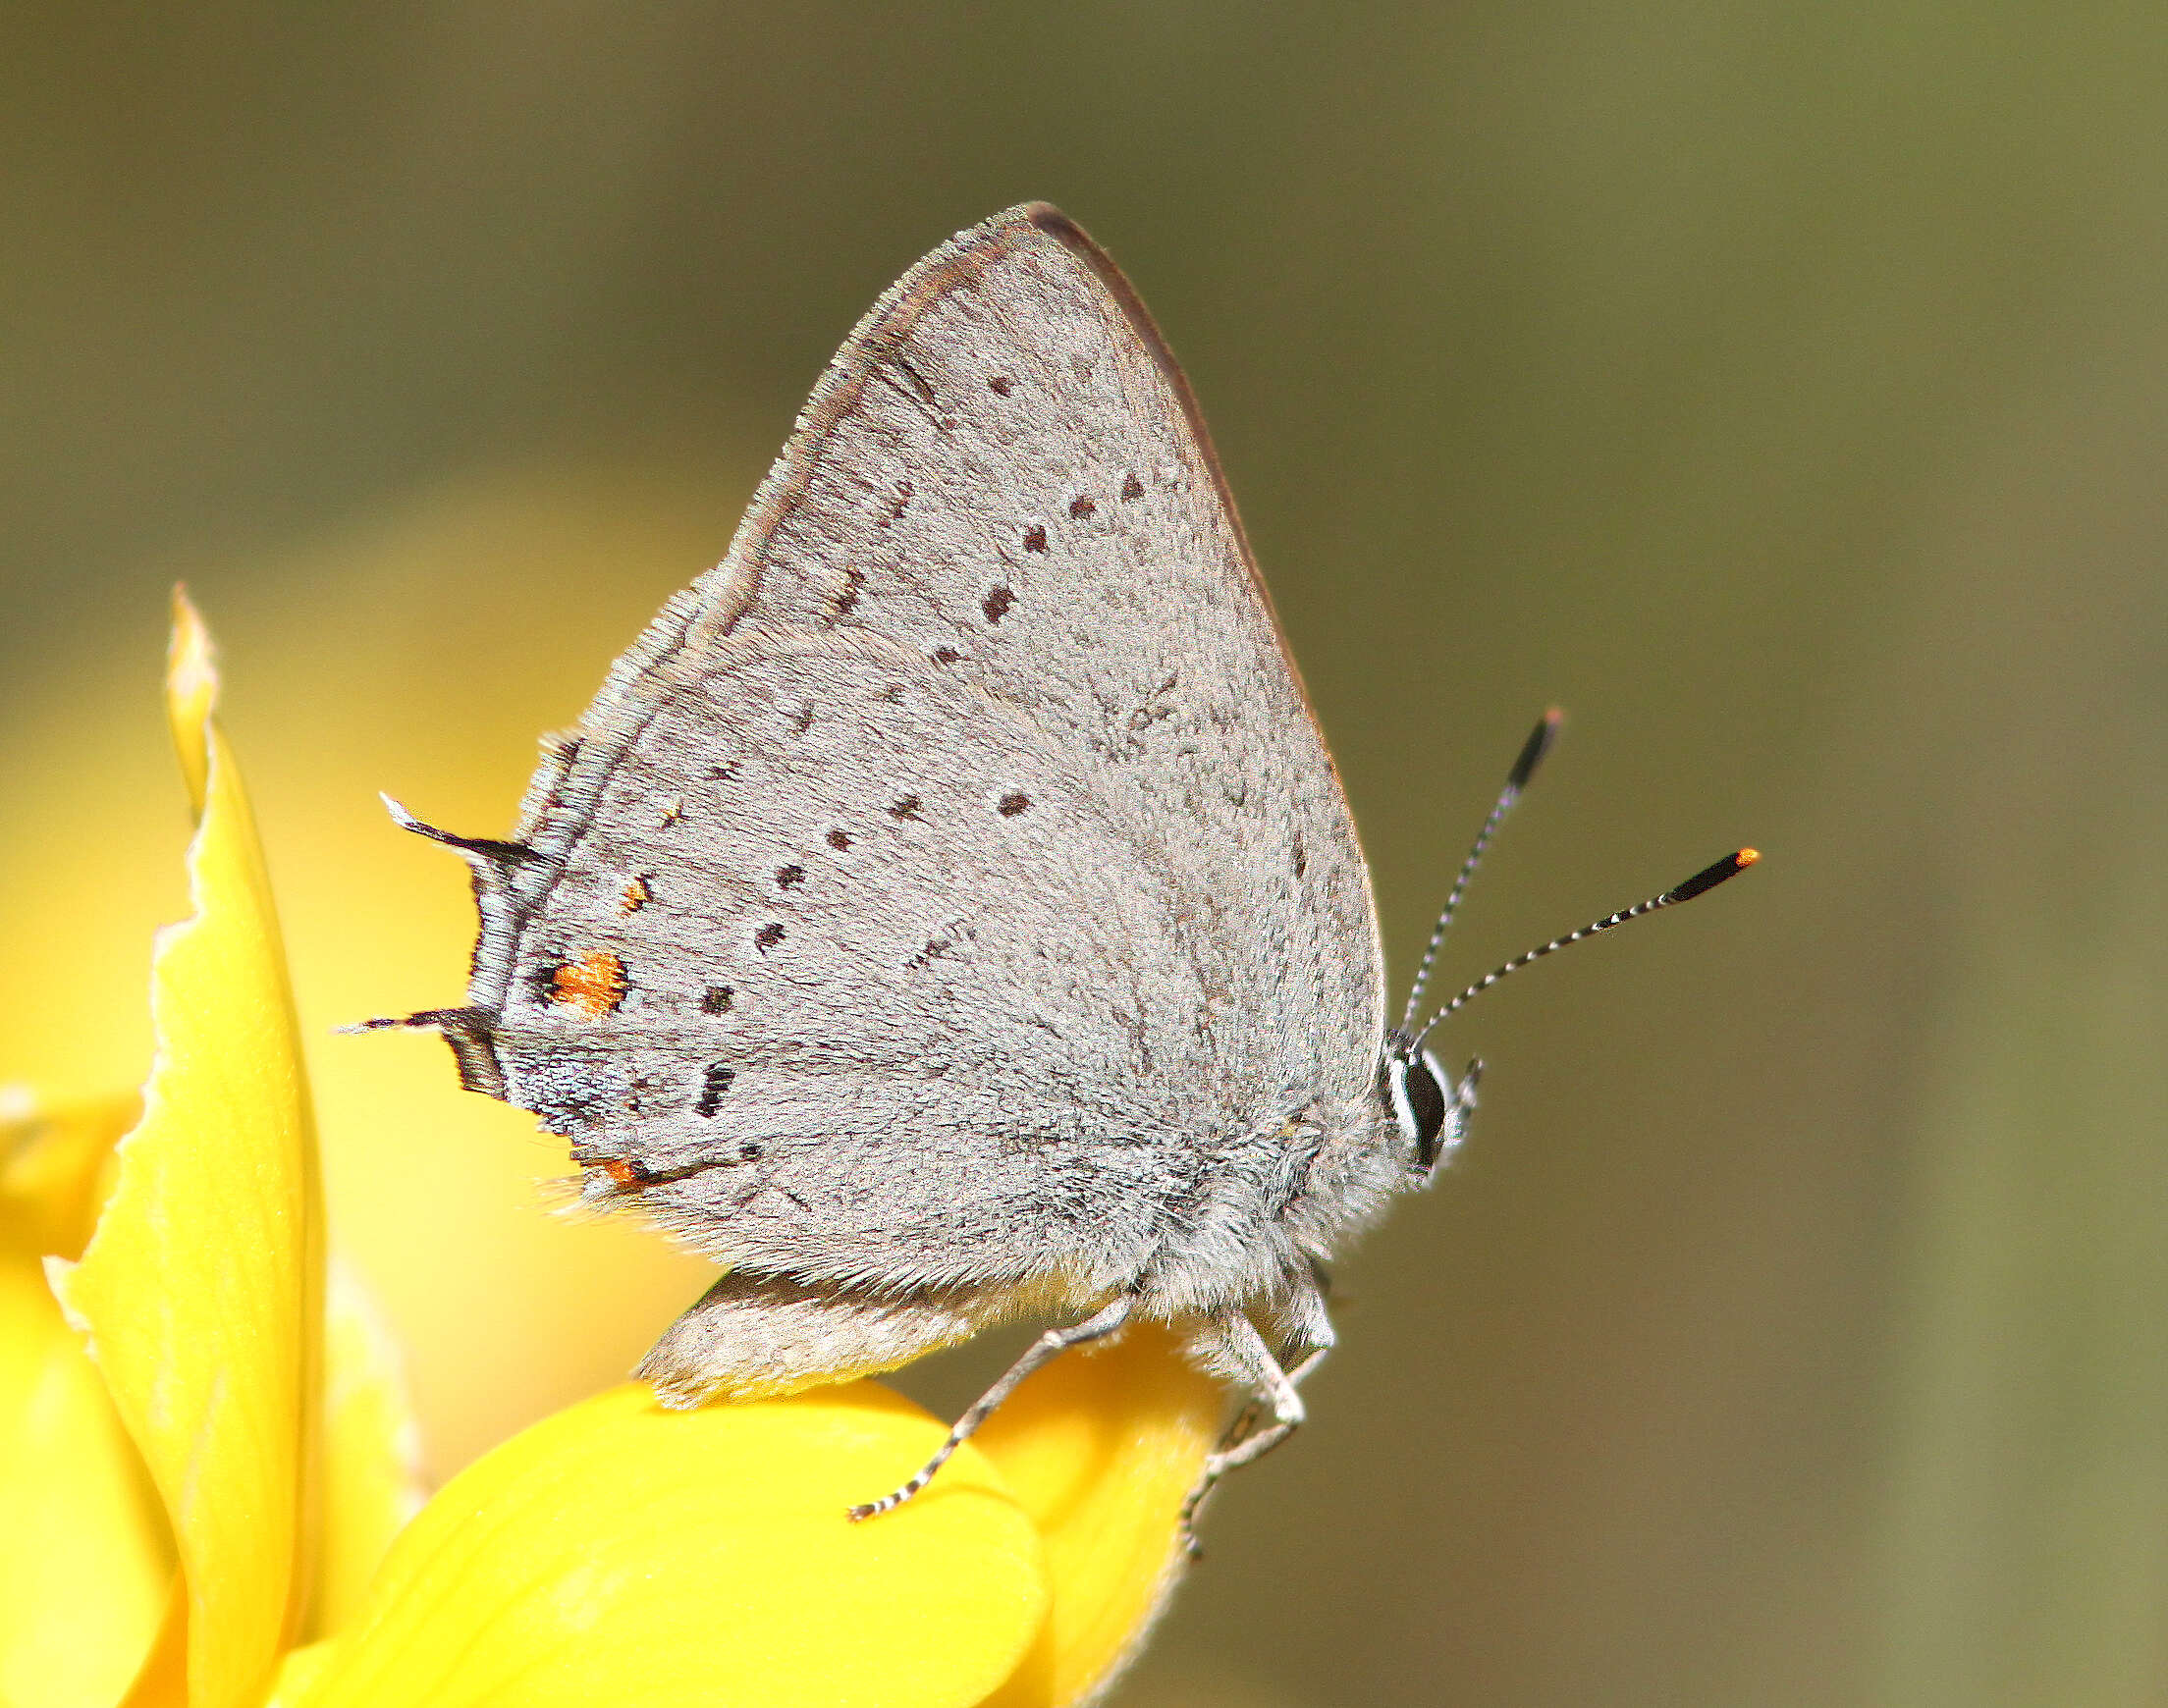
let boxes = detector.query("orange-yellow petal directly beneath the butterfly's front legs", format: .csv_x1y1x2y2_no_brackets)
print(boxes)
978,1324,1225,1708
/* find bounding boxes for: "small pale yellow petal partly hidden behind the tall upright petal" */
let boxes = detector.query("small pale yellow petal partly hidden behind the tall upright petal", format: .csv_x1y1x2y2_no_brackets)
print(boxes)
305,1261,423,1636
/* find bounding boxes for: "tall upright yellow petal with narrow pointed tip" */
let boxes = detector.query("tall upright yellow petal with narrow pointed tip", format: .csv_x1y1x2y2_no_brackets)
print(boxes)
54,603,323,1708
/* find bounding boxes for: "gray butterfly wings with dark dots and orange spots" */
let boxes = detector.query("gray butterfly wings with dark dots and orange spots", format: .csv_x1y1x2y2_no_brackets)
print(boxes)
447,206,1383,1292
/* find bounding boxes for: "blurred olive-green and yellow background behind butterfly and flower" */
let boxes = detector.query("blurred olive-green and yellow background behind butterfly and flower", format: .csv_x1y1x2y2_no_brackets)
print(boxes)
0,0,2168,1708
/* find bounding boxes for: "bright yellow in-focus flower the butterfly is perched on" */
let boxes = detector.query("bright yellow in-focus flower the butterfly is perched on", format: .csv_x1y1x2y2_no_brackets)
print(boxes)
0,603,1219,1708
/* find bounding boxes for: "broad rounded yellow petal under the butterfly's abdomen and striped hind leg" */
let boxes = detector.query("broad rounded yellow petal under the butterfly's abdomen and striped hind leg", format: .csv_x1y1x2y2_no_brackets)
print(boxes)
278,1383,1047,1708
